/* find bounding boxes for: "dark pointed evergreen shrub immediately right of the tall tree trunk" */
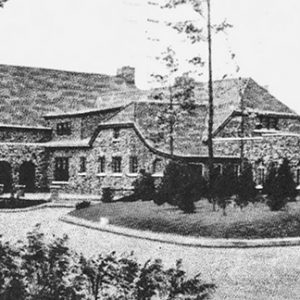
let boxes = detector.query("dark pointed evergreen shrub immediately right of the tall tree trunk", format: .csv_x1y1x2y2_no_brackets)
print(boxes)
212,164,237,216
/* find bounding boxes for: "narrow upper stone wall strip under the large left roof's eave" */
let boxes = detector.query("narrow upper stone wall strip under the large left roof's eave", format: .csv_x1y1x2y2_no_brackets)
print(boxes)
0,126,52,143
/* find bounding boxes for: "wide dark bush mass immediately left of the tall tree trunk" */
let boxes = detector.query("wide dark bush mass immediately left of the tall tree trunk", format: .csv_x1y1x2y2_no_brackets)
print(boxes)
155,161,207,213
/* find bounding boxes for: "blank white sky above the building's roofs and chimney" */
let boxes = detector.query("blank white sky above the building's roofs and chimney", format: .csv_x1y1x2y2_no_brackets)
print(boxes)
0,0,300,113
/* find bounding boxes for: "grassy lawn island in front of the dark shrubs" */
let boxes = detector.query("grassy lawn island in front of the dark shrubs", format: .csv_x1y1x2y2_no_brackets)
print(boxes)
70,200,300,239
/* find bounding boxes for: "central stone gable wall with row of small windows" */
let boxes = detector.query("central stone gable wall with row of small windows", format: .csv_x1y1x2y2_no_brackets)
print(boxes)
48,128,167,195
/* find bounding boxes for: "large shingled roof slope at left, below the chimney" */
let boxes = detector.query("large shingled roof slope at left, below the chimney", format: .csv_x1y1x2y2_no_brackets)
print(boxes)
0,65,137,126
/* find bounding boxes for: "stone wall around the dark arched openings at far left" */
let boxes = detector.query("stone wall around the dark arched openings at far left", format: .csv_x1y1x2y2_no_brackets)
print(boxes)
0,143,49,191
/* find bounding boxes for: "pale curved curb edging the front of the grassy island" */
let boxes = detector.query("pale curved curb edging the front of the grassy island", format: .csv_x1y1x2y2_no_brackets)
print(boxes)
59,215,300,249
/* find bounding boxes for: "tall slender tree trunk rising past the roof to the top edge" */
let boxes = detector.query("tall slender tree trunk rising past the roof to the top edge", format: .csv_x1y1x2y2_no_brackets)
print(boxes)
207,0,215,209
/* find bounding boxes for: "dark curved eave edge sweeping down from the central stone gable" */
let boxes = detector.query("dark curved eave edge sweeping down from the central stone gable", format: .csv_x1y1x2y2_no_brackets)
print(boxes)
89,122,239,162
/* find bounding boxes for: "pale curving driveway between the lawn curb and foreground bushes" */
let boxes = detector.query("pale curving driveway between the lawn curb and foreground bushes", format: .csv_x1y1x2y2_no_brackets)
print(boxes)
0,208,300,300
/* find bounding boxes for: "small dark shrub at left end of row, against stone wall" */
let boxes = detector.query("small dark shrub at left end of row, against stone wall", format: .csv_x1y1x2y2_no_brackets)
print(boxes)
133,169,155,201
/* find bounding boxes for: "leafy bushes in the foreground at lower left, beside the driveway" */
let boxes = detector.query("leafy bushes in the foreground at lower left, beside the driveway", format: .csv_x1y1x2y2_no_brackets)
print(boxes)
0,227,216,300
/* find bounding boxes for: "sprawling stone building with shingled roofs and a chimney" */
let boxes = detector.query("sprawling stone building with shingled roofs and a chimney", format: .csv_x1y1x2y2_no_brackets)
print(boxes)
0,66,300,195
